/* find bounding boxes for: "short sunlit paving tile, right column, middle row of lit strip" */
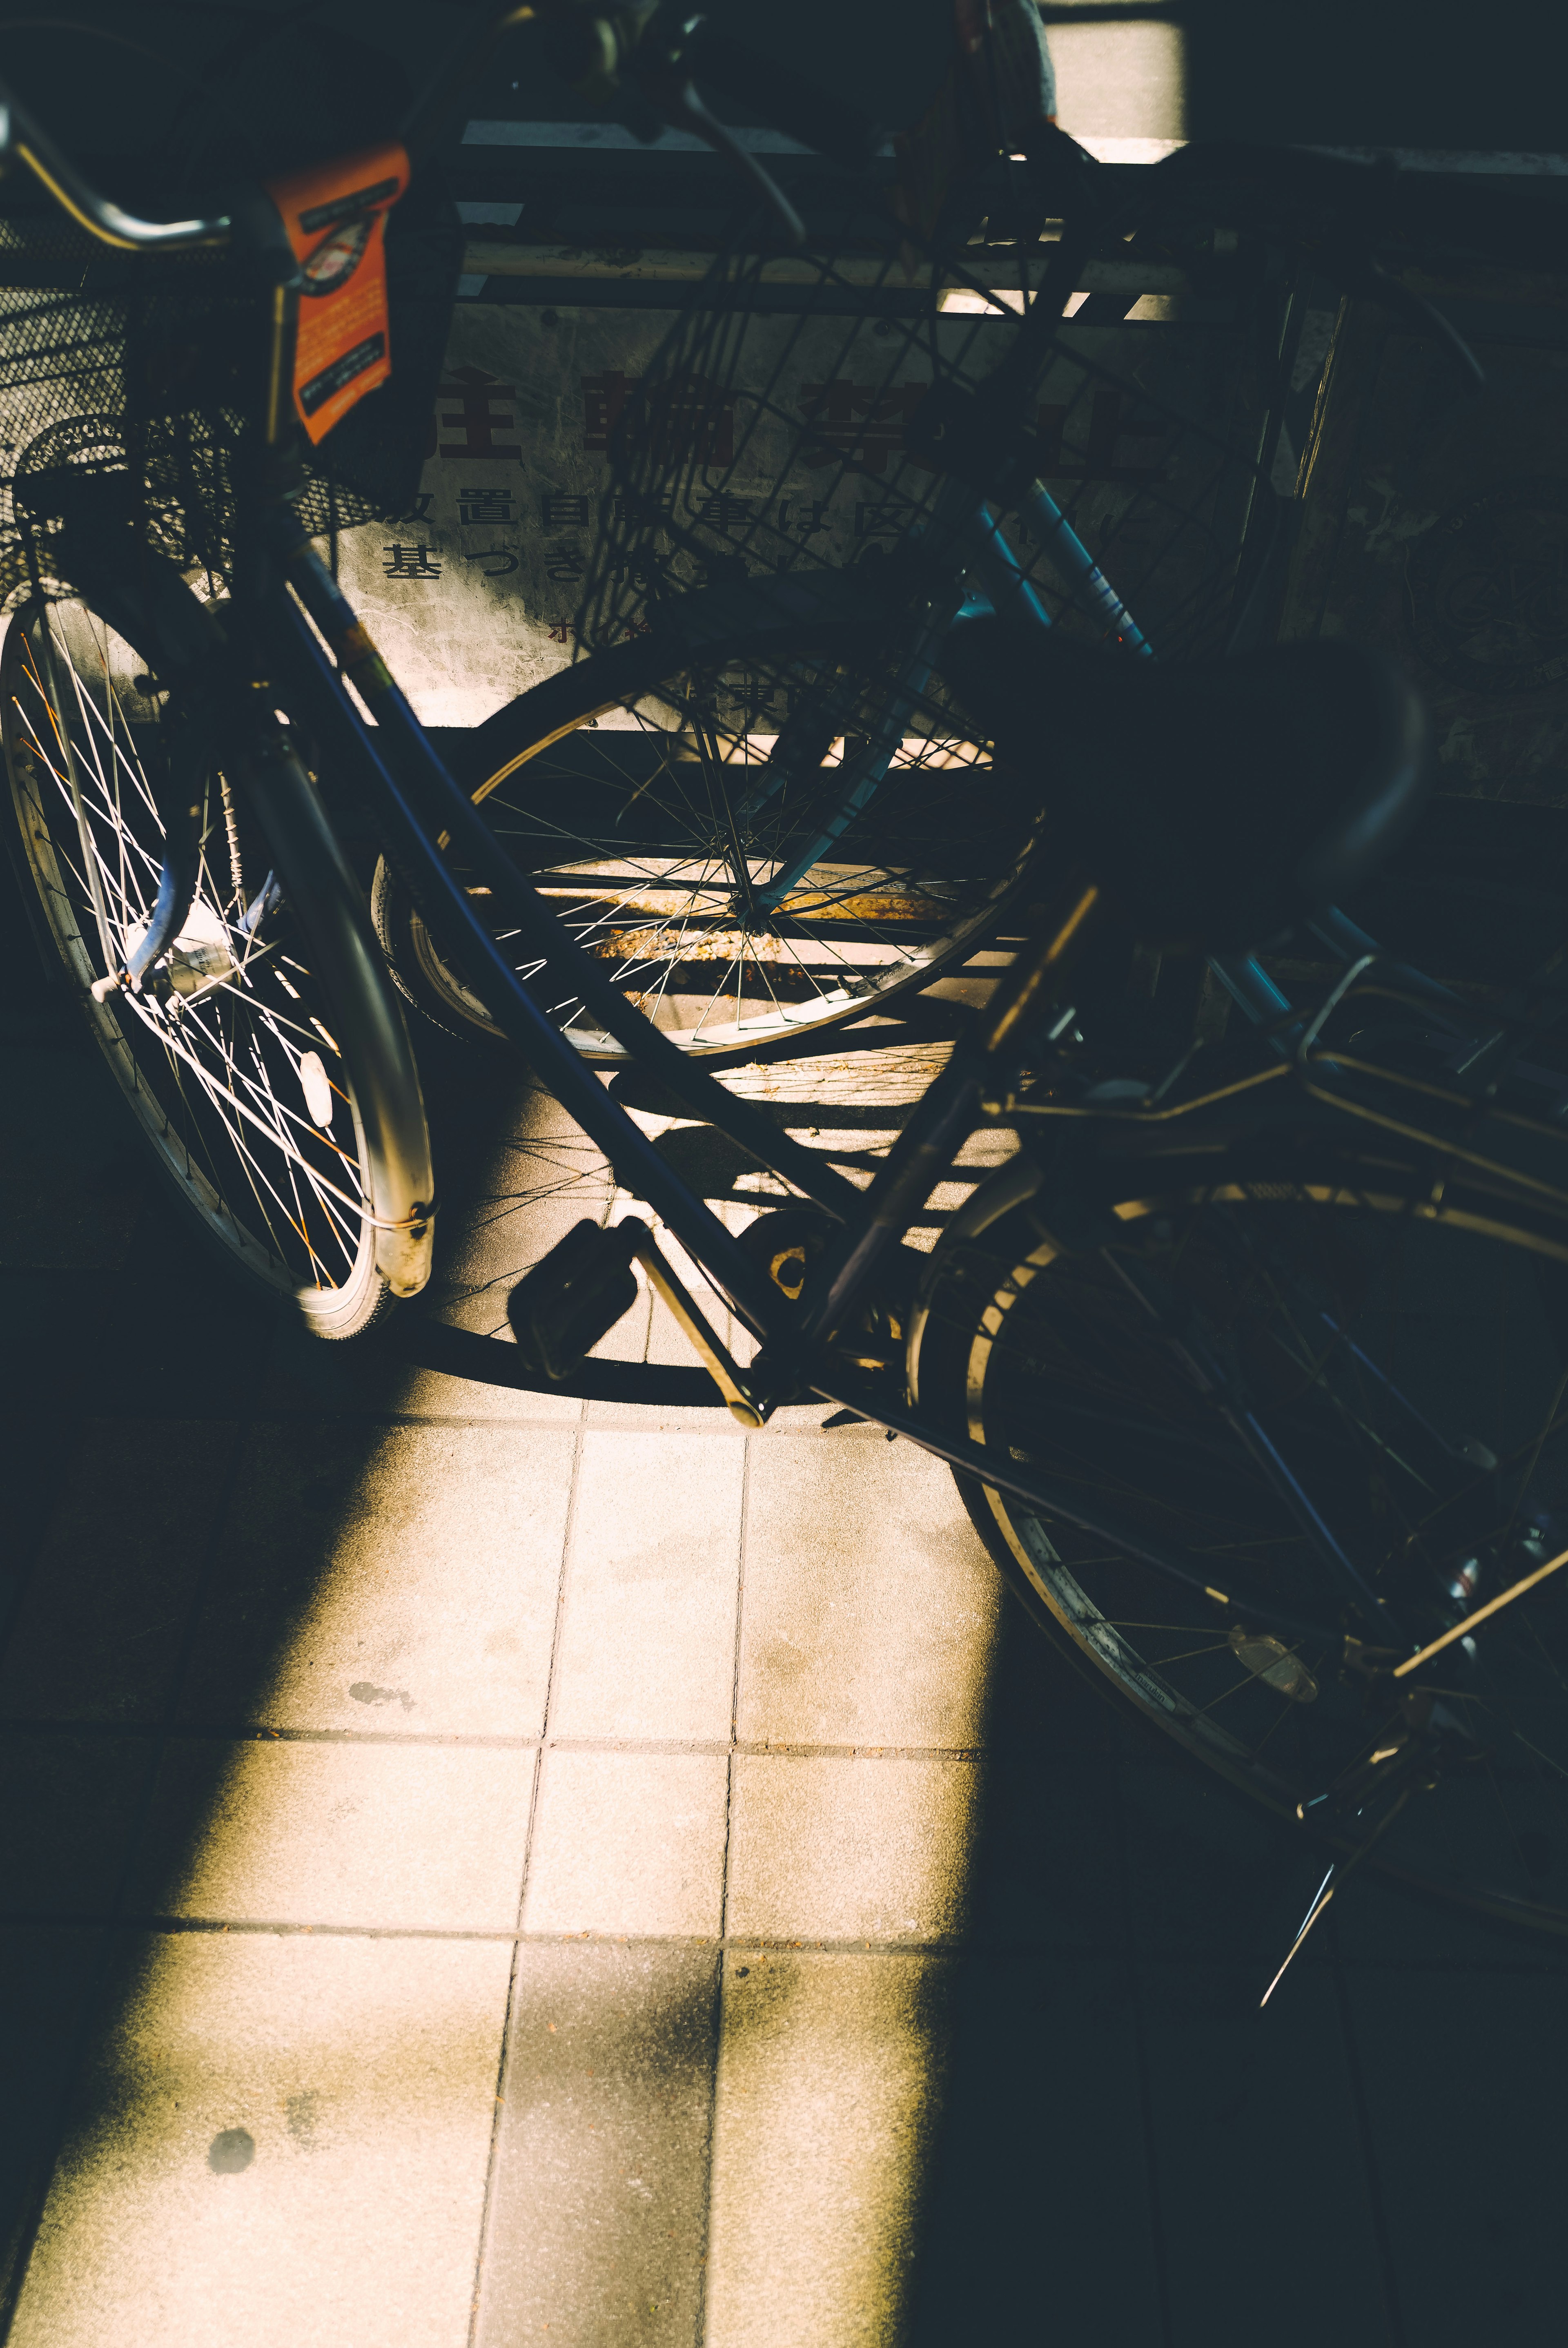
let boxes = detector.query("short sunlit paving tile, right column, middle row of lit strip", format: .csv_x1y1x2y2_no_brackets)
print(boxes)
725,1754,979,1940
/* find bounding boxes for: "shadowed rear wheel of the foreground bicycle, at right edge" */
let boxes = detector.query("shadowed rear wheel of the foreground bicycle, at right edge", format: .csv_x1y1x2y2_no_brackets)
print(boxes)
913,1129,1568,1930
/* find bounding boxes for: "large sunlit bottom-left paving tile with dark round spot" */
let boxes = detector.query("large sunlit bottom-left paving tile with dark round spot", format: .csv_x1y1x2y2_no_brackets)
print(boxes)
12,1932,512,2348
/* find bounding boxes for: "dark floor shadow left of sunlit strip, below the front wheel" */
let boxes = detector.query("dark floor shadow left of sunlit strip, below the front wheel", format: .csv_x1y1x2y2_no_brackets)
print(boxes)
0,841,563,2334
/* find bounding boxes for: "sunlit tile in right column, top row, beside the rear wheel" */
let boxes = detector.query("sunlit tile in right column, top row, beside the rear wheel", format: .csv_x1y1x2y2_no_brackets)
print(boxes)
739,1437,1000,1745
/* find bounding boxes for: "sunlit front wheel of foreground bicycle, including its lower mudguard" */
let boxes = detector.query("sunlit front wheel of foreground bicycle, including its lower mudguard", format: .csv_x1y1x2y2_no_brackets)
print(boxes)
0,601,432,1338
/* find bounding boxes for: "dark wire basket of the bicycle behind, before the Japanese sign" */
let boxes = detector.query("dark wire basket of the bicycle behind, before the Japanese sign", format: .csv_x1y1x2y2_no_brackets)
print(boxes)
577,191,1272,685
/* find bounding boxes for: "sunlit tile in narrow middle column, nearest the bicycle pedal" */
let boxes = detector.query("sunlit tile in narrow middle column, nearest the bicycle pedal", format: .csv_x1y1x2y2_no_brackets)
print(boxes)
549,1430,746,1742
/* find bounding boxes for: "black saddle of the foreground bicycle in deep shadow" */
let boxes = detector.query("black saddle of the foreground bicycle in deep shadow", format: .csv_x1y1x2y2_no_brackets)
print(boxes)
939,620,1430,953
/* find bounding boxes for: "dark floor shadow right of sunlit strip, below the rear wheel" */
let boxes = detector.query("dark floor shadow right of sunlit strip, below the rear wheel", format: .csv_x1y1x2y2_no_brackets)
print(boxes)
911,1608,1568,2348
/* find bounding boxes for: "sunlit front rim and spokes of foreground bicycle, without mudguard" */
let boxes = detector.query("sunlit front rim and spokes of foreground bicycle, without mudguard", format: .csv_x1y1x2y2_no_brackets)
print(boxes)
0,601,390,1336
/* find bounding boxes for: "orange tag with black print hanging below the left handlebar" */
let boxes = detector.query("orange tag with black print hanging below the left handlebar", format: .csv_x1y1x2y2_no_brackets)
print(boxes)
267,145,408,444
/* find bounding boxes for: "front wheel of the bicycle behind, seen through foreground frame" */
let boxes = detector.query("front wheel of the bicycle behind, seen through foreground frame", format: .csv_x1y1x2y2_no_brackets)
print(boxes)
371,575,1035,1064
